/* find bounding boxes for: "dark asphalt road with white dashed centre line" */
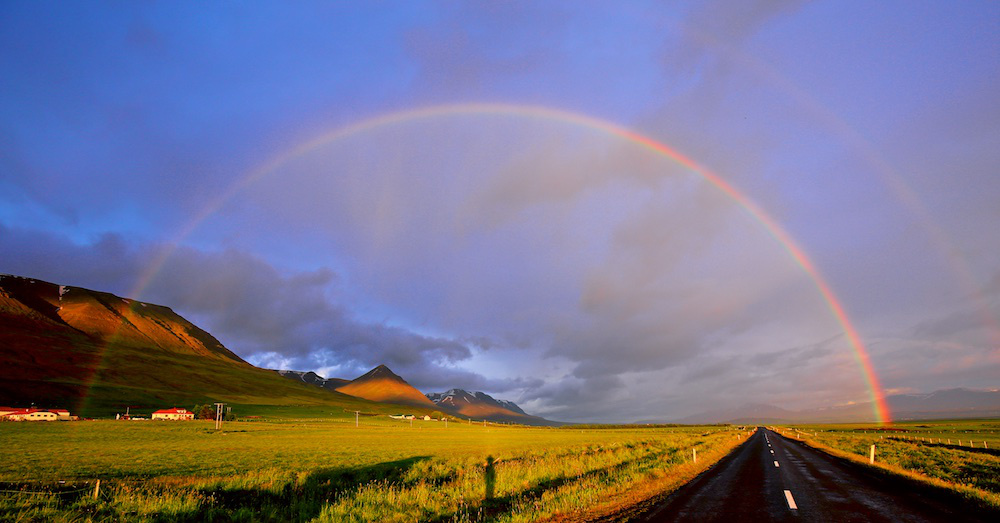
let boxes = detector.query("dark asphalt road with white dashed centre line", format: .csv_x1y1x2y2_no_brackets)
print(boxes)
636,429,1000,523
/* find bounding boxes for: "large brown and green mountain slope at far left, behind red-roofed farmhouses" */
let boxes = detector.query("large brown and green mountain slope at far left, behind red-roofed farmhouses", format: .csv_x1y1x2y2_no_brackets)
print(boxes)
0,275,406,416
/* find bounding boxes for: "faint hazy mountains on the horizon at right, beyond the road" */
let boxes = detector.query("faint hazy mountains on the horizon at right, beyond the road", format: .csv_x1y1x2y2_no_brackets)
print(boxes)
673,388,1000,424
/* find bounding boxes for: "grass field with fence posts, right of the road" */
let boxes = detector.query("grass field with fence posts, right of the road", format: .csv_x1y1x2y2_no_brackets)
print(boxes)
780,420,1000,508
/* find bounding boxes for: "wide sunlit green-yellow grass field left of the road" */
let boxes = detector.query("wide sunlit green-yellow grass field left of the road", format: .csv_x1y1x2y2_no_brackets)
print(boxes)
0,416,745,522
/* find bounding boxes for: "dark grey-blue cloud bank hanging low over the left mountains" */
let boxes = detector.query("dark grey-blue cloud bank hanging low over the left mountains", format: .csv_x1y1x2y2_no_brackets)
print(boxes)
0,225,516,391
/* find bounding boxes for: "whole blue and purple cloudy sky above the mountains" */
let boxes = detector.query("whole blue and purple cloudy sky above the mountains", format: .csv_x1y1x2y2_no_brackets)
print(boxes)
0,0,1000,422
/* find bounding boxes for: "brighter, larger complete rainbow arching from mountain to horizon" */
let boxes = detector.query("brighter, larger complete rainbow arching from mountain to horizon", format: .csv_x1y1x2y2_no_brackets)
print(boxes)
132,103,891,423
